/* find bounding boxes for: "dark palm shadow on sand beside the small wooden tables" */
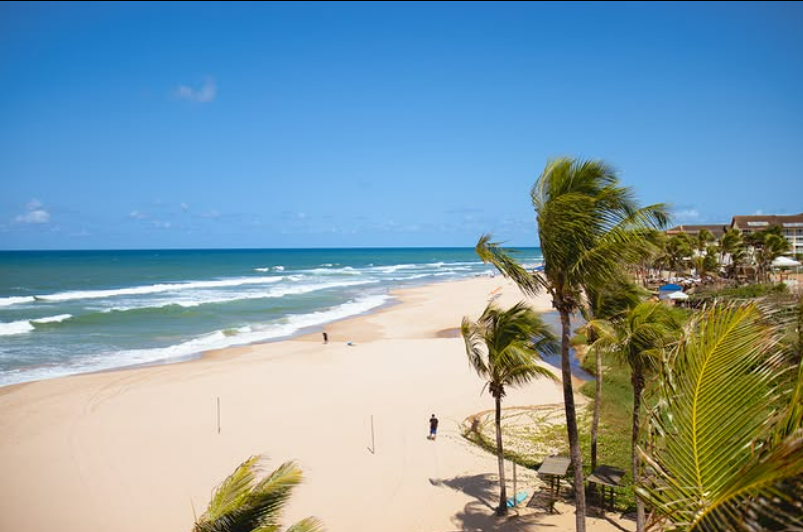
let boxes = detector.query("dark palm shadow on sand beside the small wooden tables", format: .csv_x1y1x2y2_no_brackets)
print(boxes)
429,474,544,532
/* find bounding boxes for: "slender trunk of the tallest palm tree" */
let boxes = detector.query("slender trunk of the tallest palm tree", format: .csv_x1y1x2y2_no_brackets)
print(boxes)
558,306,586,532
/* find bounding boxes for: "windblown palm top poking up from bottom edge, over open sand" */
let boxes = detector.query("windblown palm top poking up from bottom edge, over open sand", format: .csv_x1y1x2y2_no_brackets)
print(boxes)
193,456,323,532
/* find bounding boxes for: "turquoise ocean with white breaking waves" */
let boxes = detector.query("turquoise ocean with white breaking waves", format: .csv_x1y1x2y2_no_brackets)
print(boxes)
0,248,541,386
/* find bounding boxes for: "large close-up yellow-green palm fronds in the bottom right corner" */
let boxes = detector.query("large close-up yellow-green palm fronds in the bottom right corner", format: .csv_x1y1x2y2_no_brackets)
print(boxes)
639,304,803,532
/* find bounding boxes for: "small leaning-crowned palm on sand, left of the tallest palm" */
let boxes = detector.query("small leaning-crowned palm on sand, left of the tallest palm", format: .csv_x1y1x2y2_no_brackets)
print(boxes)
461,302,557,515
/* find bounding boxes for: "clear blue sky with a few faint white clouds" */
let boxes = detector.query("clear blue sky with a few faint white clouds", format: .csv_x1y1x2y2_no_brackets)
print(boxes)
0,2,803,249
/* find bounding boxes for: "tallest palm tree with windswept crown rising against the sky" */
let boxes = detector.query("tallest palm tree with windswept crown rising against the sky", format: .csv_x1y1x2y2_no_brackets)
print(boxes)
477,157,668,532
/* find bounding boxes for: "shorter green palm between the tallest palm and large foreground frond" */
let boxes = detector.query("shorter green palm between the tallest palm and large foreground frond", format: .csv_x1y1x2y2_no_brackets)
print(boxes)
603,301,683,532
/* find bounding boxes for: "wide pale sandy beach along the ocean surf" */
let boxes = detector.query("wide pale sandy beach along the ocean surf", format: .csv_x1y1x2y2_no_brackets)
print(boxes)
0,278,634,532
